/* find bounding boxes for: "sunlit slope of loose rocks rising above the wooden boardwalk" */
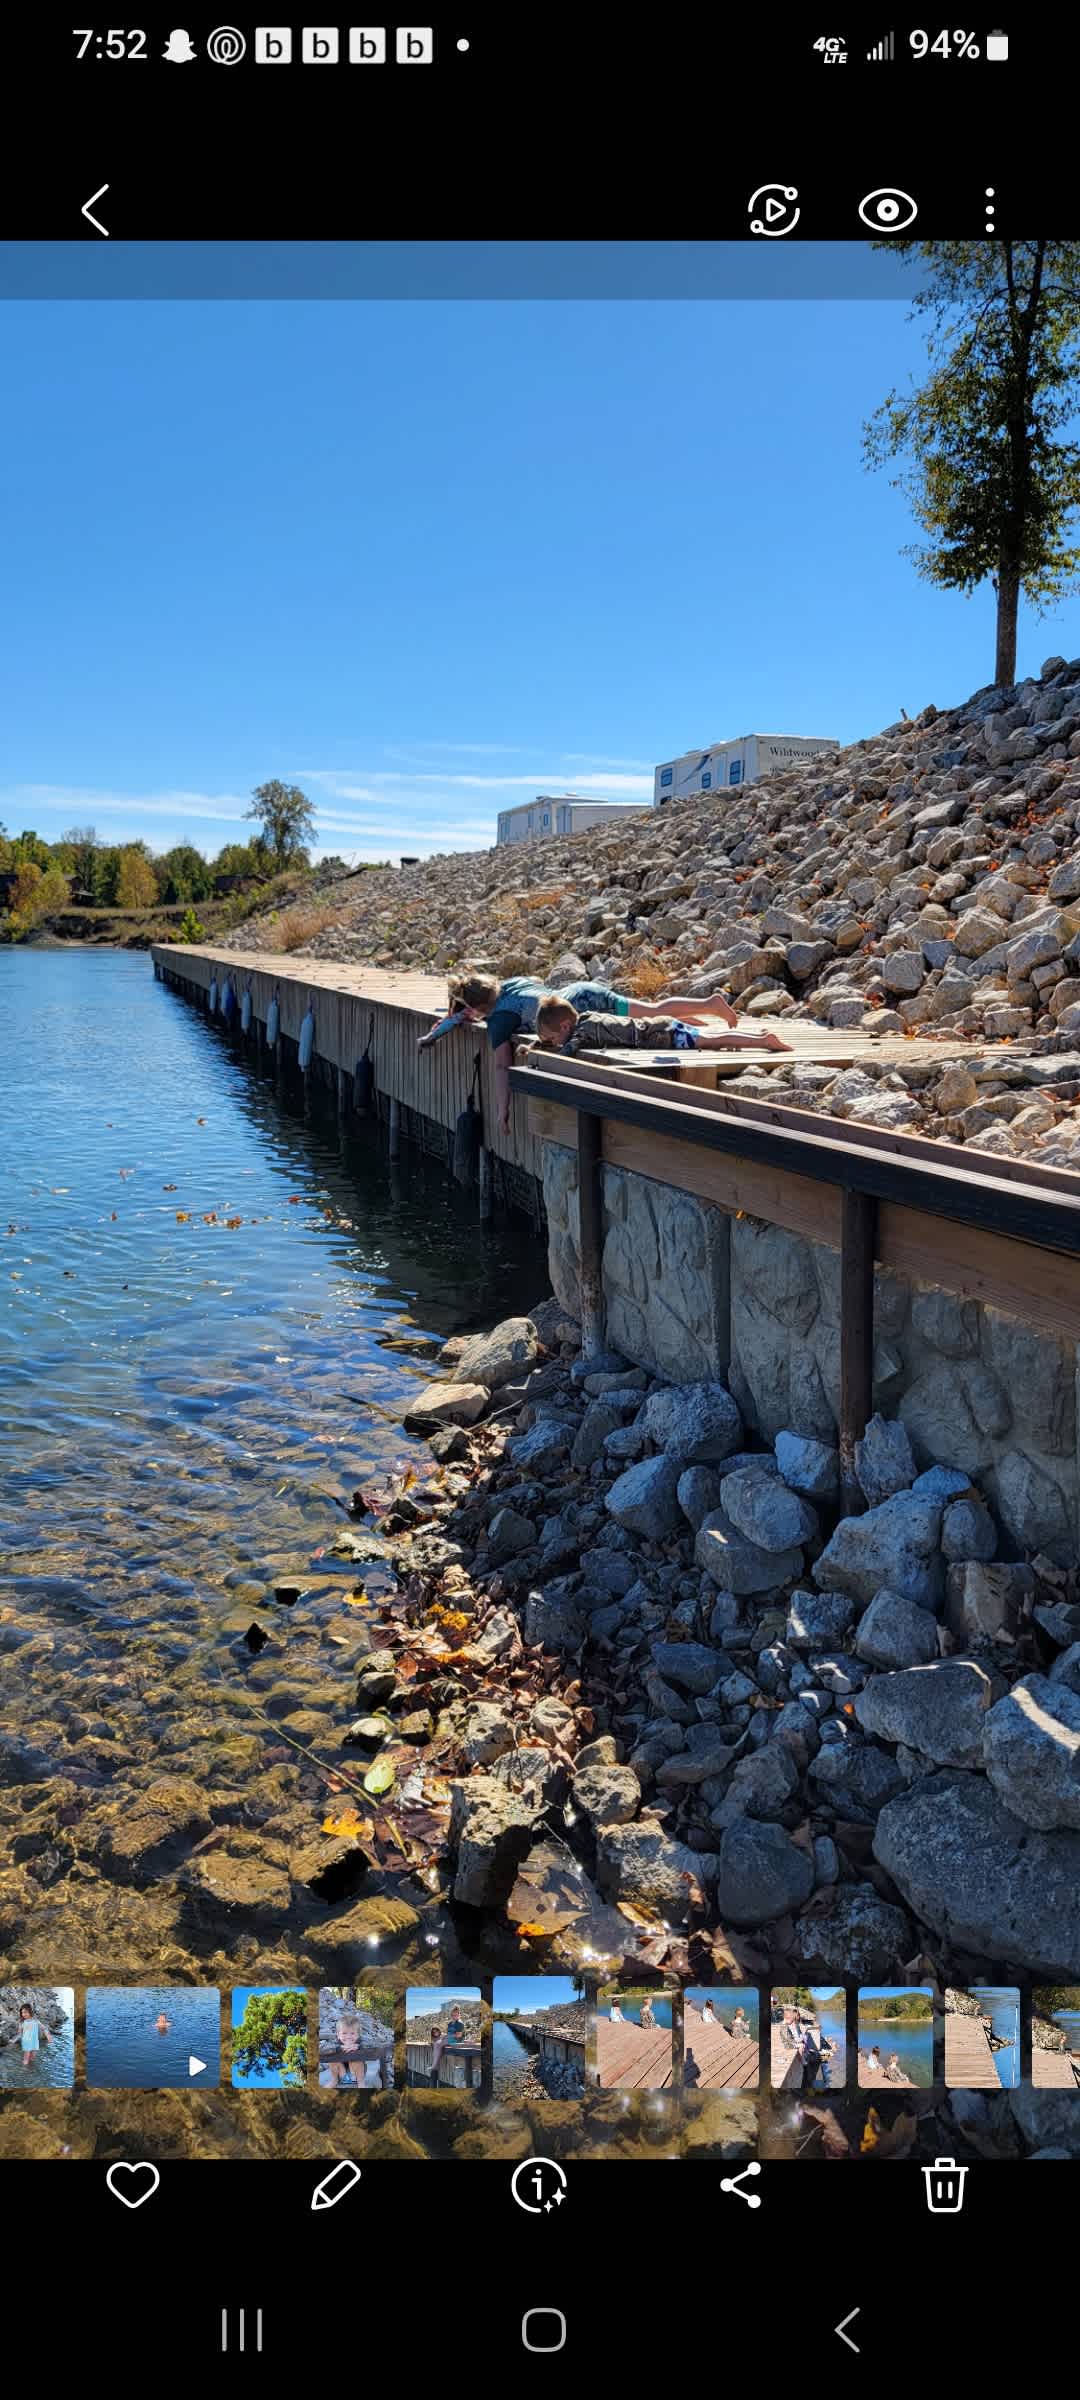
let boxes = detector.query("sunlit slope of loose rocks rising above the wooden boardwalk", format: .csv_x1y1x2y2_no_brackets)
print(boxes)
223,658,1080,1166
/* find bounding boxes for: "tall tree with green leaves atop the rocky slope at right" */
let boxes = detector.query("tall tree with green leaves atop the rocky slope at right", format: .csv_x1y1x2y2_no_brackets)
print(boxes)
864,242,1080,686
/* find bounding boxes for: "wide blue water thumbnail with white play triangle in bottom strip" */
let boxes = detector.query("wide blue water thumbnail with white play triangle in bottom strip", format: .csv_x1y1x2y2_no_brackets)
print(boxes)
86,1985,221,2090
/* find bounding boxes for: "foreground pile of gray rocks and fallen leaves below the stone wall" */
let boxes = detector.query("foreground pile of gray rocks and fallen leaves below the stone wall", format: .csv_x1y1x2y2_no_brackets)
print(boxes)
358,1303,1080,1990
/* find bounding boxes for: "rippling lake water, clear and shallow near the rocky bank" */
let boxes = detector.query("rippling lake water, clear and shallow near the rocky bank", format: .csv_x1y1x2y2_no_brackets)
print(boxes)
0,950,547,1982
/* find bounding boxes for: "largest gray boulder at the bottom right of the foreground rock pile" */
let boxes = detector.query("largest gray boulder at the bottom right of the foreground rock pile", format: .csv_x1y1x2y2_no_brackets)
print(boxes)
874,1769,1080,1982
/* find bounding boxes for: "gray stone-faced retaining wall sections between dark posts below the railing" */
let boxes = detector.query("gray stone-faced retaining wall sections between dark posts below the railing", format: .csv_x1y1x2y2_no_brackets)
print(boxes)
545,1142,1080,1565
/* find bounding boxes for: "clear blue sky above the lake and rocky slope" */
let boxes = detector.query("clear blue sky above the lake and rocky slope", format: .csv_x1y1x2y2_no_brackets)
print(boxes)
0,279,1080,859
